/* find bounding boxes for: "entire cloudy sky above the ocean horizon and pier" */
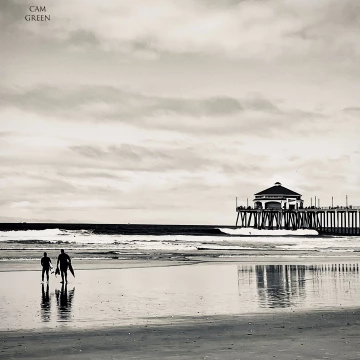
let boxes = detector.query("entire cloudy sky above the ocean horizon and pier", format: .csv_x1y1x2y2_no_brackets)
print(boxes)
0,0,360,225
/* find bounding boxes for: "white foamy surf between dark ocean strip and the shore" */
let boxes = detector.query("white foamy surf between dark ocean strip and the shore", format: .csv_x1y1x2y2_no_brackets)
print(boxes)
0,227,360,253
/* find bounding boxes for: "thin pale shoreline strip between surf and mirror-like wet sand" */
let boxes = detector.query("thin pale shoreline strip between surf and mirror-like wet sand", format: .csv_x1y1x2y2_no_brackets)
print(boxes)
0,250,360,272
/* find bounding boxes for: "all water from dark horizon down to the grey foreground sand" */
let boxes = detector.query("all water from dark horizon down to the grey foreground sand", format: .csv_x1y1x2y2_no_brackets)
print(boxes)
0,223,360,331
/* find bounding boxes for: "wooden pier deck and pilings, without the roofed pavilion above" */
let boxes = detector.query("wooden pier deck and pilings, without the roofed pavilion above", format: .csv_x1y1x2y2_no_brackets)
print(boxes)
236,206,360,235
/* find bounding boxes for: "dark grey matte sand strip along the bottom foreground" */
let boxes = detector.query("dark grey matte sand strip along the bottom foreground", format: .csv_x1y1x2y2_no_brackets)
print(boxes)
0,309,360,360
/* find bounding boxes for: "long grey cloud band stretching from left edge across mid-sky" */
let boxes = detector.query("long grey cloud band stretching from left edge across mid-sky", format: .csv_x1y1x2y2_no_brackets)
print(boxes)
0,86,328,137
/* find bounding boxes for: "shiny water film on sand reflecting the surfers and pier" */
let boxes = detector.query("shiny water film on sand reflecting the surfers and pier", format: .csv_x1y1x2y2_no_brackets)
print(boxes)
0,262,360,330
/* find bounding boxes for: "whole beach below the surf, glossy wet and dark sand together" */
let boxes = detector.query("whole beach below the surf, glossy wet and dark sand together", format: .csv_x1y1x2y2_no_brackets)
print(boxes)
0,257,360,360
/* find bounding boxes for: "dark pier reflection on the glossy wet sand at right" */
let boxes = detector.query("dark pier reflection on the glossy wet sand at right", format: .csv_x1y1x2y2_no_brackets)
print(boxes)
238,263,360,308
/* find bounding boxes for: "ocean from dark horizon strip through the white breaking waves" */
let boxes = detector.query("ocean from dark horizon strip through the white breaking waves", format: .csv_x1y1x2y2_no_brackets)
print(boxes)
0,223,360,261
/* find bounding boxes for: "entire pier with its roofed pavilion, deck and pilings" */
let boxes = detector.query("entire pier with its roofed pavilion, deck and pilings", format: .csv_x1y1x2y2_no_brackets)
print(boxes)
235,182,360,235
